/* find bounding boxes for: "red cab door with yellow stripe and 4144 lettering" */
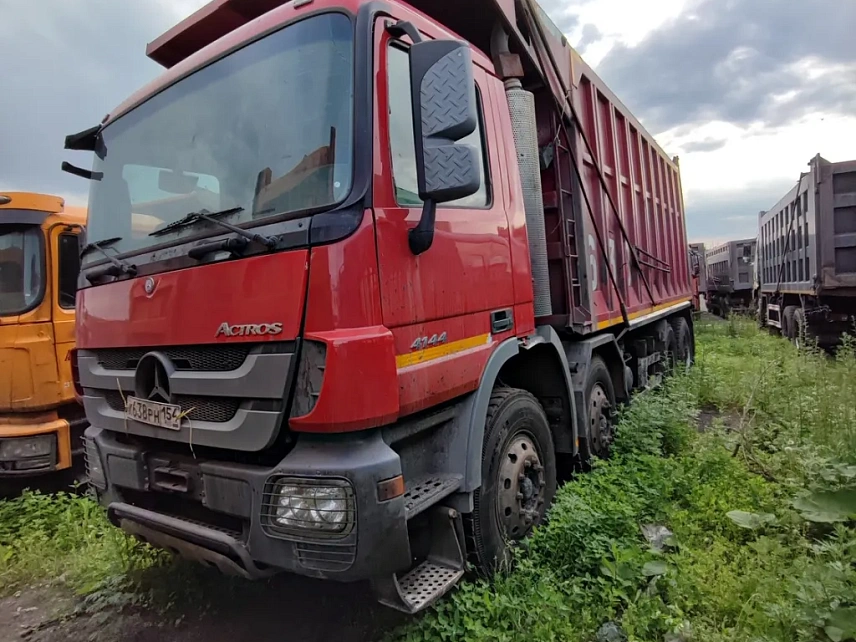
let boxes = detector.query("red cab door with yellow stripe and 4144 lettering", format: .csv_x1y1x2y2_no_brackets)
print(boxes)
373,15,514,414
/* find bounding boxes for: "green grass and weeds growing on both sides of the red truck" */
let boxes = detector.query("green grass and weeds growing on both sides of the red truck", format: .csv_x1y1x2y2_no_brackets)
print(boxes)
0,320,856,642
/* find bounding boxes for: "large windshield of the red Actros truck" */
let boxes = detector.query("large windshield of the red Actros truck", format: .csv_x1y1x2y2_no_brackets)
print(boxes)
85,13,353,262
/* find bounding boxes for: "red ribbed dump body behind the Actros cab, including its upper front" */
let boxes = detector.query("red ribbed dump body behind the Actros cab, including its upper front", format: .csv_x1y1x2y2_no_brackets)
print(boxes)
402,0,692,334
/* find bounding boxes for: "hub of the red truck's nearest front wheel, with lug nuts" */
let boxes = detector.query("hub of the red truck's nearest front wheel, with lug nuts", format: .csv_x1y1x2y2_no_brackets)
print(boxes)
497,434,547,539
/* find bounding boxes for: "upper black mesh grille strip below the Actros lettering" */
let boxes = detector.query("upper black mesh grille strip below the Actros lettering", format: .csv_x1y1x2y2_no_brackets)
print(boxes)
95,344,252,372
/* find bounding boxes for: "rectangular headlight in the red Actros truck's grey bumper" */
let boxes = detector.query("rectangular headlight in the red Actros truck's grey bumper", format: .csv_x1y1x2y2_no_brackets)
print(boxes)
265,478,355,536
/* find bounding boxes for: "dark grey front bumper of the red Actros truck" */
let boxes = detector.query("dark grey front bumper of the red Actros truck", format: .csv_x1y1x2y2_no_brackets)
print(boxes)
86,427,411,581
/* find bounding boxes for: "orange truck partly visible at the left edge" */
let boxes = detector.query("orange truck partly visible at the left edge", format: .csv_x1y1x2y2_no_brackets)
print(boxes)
0,192,87,481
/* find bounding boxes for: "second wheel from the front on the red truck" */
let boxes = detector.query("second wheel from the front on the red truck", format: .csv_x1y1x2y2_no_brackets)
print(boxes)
580,356,615,465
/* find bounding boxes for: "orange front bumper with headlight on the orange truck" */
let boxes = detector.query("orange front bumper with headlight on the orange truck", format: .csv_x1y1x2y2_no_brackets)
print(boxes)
0,414,83,477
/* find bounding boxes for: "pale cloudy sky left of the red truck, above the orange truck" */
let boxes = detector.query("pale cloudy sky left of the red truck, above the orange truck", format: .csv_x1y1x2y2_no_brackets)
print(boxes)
0,0,202,201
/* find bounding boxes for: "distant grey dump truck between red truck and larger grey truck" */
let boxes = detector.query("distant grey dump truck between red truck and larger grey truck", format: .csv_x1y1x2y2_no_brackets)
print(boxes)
705,239,757,317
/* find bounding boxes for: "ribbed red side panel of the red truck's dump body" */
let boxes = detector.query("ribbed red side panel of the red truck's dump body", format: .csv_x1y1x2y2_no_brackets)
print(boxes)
574,63,692,330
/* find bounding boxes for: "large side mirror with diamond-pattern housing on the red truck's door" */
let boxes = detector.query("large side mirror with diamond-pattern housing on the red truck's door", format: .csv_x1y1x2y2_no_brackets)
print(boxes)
408,40,481,255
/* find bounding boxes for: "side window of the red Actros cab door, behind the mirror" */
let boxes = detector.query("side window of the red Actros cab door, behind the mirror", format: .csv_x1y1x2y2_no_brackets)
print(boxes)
387,44,490,208
